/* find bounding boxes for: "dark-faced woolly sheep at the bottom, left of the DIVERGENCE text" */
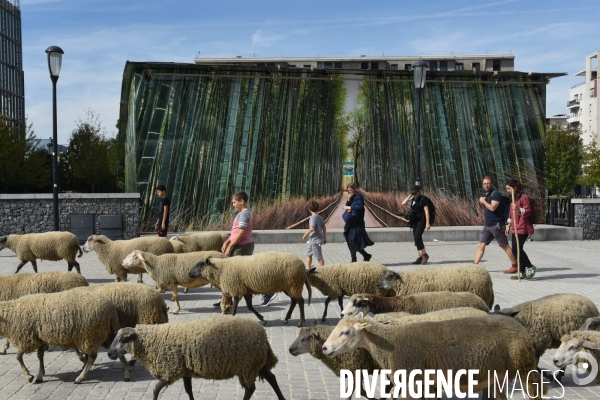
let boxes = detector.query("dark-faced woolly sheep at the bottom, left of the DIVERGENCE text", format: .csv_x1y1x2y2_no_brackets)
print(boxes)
108,316,284,400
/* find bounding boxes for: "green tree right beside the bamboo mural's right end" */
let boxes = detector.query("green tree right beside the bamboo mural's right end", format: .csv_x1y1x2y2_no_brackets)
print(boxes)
546,125,583,195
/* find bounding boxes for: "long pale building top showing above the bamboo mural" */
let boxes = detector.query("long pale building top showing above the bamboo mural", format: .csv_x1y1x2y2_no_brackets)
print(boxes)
194,53,515,72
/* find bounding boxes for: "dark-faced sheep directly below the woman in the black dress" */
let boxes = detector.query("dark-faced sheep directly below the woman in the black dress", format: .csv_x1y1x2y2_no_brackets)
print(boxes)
306,261,392,321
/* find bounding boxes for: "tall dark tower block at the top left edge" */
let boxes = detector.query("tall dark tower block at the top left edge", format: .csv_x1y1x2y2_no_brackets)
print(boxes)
0,0,25,125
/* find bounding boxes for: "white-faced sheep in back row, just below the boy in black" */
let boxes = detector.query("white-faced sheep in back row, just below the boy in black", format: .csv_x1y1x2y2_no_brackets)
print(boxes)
83,235,175,283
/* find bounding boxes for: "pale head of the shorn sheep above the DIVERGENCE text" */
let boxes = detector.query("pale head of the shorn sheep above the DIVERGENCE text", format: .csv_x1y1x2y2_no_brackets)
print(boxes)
323,313,370,357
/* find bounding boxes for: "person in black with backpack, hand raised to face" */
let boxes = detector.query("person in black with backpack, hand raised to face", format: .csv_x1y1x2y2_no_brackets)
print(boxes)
402,185,435,265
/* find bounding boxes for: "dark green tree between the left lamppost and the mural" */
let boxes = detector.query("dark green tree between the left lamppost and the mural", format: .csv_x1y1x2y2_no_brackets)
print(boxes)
59,110,117,193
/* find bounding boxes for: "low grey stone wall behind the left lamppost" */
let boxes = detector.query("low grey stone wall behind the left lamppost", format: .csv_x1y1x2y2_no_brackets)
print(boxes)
0,193,140,239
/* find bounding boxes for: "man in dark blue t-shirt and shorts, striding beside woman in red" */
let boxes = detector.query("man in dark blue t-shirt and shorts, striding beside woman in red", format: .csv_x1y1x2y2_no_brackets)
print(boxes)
474,176,517,274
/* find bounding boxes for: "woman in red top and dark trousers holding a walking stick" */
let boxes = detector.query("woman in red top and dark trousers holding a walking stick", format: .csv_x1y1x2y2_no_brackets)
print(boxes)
505,179,537,279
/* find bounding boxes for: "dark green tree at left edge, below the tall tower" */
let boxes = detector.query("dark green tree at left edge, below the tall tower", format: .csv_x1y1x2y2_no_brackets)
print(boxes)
0,120,51,193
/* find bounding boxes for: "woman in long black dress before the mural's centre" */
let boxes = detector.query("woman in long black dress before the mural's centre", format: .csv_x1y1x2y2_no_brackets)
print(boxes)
343,182,375,262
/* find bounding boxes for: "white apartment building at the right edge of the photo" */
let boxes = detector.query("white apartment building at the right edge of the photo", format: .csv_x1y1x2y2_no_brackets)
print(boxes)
567,51,600,144
